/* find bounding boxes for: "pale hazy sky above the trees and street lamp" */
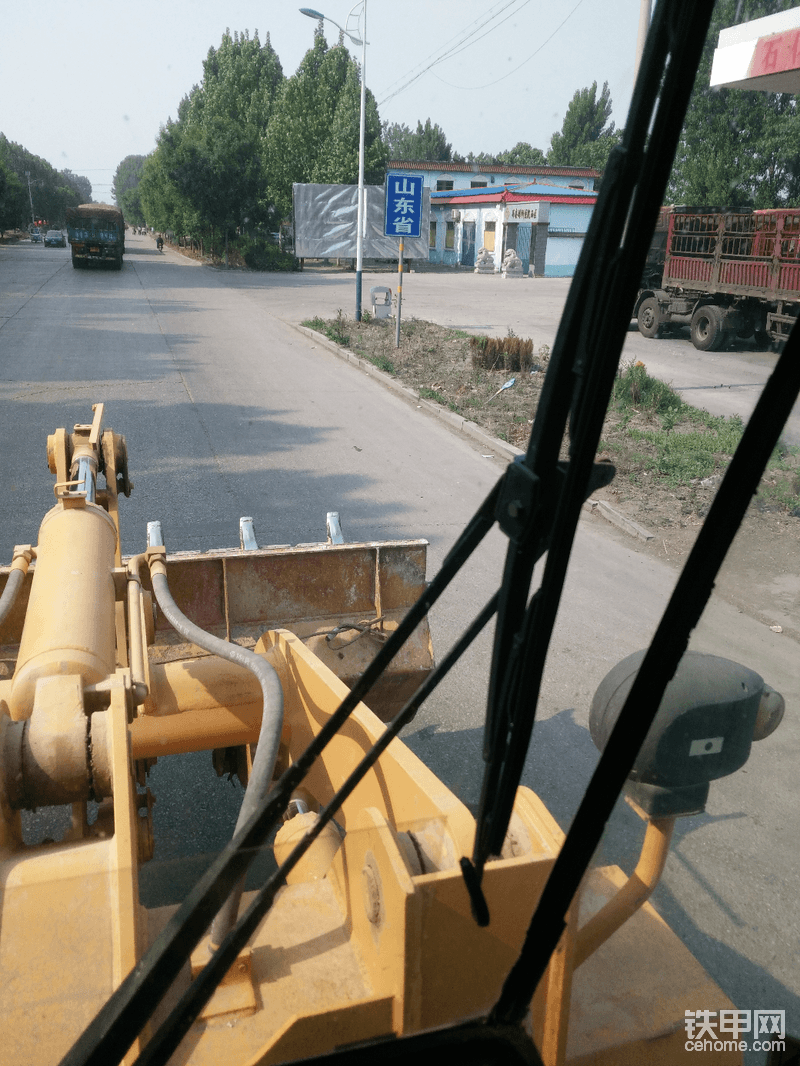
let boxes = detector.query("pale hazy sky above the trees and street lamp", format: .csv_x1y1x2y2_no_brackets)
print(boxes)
0,0,640,201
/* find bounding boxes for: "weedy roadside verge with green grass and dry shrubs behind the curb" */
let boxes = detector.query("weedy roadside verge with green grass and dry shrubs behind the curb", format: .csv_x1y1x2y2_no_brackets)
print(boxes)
303,311,800,516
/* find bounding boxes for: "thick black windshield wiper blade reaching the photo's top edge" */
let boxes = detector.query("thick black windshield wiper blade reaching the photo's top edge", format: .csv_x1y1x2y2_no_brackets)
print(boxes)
466,0,714,903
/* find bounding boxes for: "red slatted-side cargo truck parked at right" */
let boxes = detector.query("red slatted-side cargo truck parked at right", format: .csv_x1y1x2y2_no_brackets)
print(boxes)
634,207,800,352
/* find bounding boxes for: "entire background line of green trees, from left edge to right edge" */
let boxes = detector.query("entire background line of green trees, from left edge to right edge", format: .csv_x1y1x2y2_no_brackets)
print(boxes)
0,0,800,243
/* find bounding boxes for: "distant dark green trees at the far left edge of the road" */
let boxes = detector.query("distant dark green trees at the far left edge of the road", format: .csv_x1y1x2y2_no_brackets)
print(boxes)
0,133,92,232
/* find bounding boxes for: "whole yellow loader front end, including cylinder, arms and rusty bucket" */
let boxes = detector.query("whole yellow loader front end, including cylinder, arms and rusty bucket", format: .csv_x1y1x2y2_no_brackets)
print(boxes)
0,406,740,1066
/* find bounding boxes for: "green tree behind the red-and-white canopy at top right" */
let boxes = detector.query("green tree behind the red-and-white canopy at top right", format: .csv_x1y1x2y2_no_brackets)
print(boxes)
668,0,800,208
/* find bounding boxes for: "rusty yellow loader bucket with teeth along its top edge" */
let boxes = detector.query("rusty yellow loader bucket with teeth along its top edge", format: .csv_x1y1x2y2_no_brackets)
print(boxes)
0,540,433,722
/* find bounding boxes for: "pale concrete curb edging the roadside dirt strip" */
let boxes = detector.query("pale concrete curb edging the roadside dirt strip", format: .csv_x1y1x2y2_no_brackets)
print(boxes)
294,322,655,543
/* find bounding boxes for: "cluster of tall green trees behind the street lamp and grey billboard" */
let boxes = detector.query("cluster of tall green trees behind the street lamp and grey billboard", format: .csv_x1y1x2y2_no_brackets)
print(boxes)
114,23,386,263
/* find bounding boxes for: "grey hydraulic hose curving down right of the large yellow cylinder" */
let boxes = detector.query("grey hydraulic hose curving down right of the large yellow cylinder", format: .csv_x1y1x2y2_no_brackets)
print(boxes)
148,549,284,951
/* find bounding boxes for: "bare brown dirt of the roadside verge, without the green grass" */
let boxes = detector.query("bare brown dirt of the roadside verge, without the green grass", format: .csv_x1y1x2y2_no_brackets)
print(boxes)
305,316,800,639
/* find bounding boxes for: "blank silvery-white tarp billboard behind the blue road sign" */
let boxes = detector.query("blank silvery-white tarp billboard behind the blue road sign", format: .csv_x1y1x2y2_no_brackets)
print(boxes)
292,184,431,259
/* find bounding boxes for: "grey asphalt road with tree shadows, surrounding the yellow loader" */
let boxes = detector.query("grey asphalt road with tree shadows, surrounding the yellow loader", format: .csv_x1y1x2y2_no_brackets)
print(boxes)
0,238,800,1064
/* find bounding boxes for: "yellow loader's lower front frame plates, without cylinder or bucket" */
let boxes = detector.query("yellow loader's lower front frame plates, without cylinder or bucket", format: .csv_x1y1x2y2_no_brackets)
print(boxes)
0,618,737,1066
